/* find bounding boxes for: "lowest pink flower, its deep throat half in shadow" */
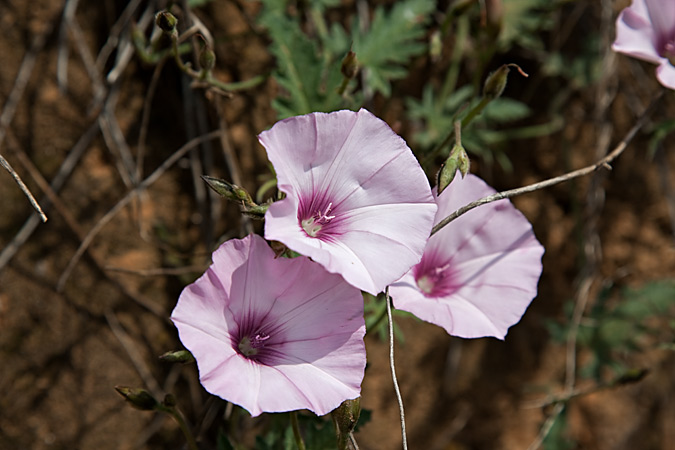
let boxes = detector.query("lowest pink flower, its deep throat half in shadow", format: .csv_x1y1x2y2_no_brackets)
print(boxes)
171,235,366,416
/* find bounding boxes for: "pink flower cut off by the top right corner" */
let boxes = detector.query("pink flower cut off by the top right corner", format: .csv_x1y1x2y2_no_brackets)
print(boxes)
612,0,675,89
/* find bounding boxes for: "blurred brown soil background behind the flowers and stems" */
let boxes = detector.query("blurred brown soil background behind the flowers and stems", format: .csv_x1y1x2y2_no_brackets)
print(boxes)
0,0,675,450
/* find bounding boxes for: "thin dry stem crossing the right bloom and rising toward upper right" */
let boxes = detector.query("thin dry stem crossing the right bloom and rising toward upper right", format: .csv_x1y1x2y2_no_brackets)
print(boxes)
431,90,665,236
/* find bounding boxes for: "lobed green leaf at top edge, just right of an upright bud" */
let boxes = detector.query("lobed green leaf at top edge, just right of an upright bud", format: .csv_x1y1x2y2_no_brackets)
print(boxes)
352,0,436,97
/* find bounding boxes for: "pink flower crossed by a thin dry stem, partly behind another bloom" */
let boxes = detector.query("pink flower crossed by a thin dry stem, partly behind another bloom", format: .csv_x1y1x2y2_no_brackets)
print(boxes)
389,175,544,339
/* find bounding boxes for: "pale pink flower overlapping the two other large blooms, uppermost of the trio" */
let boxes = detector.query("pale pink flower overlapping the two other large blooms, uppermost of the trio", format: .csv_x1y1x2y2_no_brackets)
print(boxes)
259,109,436,294
